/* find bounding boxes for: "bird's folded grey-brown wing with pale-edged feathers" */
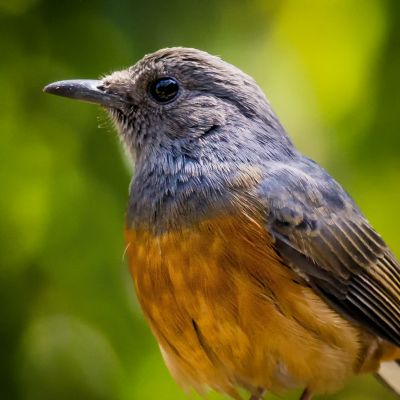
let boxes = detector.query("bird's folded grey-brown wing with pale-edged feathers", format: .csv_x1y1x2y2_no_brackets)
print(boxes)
259,159,400,346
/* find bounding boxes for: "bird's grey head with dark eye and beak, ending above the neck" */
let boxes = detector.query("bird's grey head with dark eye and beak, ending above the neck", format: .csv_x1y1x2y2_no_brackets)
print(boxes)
44,47,289,164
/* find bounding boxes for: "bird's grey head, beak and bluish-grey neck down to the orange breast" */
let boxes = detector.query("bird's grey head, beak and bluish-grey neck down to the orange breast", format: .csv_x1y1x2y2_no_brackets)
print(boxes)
44,48,295,230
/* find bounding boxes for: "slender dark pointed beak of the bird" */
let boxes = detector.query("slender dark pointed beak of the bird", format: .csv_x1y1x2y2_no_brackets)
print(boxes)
43,79,127,108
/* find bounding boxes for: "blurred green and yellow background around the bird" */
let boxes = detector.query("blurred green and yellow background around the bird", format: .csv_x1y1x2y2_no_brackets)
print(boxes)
0,0,400,400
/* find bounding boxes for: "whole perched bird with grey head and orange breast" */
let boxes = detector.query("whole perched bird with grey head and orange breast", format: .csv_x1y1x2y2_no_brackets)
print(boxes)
44,47,400,400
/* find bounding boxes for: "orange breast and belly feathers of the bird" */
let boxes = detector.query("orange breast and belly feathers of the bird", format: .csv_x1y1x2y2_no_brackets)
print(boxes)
126,212,396,397
